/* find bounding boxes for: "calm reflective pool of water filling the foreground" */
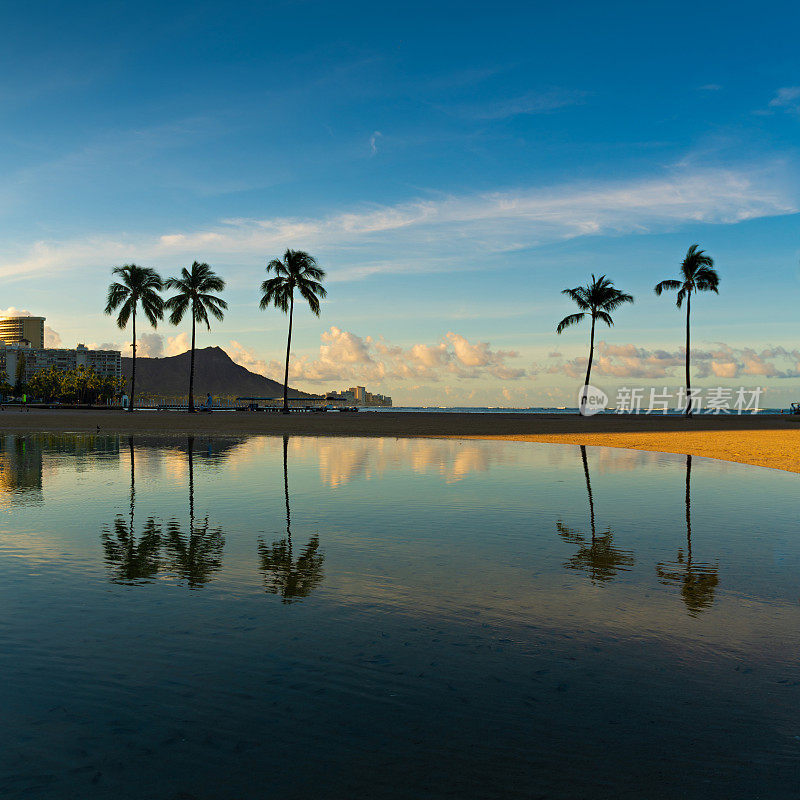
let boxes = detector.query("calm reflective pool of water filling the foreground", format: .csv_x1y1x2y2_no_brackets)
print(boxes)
0,435,800,800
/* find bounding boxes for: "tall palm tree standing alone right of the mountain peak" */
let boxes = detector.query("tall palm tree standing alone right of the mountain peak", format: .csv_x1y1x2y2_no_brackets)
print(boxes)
259,250,328,414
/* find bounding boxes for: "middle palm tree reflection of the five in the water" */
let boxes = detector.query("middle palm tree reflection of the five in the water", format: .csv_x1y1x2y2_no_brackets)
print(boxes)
258,436,325,603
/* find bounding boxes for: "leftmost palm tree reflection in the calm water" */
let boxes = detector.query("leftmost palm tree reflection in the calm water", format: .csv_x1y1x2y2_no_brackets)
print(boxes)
100,436,161,584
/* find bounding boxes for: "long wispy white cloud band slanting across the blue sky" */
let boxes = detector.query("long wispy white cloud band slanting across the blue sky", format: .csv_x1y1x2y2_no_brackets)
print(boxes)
0,165,797,281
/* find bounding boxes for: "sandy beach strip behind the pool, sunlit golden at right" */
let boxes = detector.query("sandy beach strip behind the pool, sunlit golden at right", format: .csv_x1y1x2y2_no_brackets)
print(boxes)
0,408,800,472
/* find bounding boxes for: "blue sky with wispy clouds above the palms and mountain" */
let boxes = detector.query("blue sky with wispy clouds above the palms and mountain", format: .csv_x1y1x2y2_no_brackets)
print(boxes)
0,2,800,405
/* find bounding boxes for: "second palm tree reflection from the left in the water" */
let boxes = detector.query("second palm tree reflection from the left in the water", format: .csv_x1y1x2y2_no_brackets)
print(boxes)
164,436,225,589
